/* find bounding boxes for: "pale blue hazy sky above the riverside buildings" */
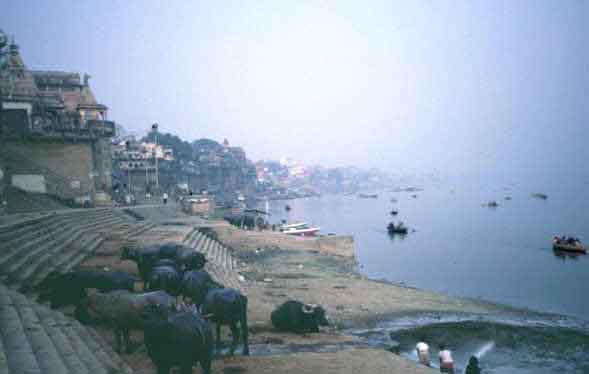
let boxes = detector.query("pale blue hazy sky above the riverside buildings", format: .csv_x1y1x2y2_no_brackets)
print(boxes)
0,0,589,173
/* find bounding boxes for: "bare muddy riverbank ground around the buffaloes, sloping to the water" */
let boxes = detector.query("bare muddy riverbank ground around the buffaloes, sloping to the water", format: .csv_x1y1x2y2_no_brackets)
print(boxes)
84,218,584,374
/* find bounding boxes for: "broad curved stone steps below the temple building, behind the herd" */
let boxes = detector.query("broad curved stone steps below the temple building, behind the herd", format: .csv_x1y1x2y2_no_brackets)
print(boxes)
0,208,154,291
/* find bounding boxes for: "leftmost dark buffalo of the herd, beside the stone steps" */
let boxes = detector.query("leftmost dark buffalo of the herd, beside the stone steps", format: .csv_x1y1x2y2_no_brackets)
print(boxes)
38,270,135,317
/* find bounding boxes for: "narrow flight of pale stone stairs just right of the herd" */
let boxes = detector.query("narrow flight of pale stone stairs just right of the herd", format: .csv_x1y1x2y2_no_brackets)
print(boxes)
183,228,242,289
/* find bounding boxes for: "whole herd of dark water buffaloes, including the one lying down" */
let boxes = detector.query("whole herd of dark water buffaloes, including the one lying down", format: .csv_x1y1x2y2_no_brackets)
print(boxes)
38,243,328,374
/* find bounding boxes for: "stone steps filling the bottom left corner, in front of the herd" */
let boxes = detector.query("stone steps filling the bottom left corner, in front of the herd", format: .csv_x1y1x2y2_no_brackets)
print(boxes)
0,284,133,374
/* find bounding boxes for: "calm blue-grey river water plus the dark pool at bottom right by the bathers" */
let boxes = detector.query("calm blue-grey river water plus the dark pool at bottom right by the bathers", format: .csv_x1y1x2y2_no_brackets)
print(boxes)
260,176,589,373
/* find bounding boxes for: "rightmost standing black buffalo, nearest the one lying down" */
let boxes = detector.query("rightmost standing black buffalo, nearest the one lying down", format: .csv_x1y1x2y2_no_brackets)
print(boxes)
201,288,249,355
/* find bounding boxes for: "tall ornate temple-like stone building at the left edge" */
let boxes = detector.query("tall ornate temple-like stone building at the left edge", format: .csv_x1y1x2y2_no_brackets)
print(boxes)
0,31,115,212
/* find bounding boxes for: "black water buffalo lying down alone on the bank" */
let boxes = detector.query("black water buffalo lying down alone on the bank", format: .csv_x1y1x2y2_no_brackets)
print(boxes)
270,300,329,334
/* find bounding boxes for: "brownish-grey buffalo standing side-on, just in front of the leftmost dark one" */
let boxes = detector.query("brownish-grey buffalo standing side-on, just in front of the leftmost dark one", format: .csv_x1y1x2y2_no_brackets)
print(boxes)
80,291,175,353
